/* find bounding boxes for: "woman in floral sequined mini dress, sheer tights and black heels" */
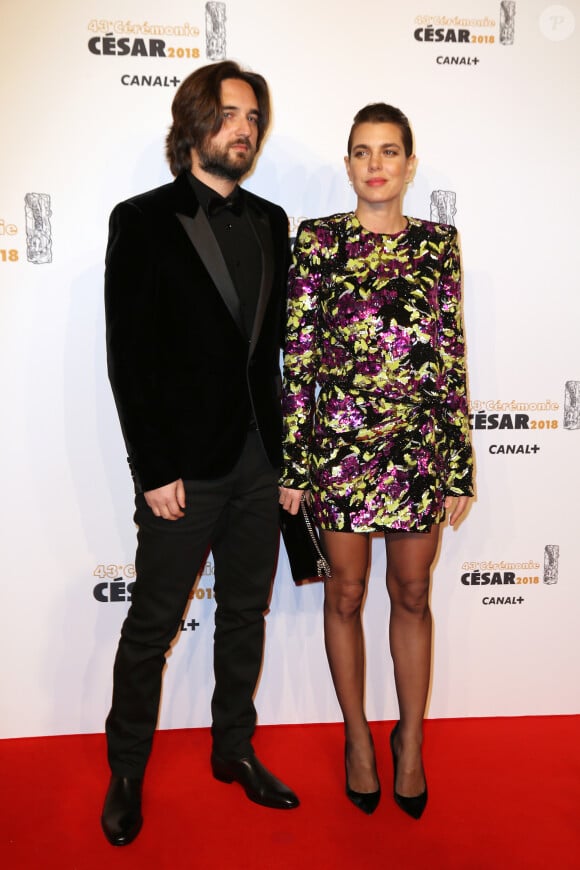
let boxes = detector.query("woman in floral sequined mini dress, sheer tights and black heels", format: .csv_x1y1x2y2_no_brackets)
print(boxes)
280,103,472,818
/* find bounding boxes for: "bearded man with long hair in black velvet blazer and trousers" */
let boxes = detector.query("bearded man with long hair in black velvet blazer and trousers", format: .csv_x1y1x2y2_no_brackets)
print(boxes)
101,61,298,846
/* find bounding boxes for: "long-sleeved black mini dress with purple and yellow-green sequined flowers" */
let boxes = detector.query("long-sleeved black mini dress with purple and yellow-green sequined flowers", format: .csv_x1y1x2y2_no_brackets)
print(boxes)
281,213,472,532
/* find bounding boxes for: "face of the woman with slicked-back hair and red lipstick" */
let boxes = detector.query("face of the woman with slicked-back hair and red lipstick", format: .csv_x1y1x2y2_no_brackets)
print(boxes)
344,123,416,205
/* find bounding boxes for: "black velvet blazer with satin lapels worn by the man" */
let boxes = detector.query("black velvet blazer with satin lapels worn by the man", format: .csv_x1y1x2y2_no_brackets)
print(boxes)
105,174,289,492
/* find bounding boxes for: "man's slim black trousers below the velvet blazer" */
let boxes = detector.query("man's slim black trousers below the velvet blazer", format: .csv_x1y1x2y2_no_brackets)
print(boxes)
106,432,278,777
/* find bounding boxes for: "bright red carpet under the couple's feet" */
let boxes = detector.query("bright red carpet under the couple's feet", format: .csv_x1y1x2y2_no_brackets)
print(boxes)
0,716,580,870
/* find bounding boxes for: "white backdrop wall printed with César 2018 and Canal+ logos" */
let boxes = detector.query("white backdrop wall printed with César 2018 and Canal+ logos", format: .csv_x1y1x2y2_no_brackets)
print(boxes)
0,0,580,737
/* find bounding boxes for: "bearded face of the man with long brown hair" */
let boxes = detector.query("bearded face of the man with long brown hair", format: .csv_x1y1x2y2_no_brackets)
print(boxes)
191,79,259,181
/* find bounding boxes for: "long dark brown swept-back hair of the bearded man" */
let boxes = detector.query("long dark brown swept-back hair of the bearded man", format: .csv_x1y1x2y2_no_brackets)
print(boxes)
165,60,270,175
